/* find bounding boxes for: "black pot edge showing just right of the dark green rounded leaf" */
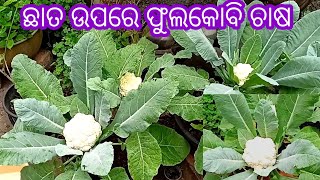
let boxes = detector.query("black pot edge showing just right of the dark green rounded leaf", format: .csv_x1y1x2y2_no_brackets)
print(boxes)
174,116,200,148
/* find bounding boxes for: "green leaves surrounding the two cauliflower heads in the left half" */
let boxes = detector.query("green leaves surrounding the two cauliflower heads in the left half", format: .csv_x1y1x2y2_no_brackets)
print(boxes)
0,31,194,180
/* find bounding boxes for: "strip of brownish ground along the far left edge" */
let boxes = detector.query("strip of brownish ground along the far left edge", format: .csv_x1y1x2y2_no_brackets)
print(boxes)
0,79,12,136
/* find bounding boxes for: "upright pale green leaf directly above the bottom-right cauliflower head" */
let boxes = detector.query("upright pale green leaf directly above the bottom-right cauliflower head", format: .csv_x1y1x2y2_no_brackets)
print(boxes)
254,99,279,140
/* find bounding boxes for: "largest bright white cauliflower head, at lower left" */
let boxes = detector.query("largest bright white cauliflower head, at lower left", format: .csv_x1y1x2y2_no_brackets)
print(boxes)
63,113,102,151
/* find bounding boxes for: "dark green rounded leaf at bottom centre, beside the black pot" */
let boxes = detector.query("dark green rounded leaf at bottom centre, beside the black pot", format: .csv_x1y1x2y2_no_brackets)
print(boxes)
149,124,190,166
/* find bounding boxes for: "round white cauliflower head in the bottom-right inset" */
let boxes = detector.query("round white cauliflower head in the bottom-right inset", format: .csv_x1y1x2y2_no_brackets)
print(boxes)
242,137,277,169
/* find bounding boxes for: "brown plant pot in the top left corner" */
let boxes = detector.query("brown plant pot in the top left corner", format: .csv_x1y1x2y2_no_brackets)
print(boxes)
0,30,43,67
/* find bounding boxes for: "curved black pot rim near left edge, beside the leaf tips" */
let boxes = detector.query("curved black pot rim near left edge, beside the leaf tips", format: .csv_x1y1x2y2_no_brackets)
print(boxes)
2,84,21,125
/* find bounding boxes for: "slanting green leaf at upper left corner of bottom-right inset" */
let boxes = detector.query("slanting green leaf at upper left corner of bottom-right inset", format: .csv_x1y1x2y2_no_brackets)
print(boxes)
213,94,256,135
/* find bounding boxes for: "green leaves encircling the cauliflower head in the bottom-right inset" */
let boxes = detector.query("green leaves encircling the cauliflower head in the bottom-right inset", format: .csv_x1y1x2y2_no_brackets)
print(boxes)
204,93,320,179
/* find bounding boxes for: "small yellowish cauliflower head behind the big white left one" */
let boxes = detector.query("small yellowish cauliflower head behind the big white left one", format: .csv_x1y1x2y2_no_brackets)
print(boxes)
120,72,142,96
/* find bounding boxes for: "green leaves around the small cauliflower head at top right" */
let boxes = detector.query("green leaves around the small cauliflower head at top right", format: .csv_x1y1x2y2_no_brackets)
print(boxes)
171,1,320,93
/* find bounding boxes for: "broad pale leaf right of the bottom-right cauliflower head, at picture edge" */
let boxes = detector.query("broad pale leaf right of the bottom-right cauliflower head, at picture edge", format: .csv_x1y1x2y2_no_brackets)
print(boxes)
276,140,320,174
